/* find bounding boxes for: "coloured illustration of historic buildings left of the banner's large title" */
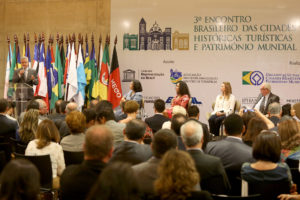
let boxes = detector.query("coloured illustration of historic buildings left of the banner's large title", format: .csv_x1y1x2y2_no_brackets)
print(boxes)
123,18,189,50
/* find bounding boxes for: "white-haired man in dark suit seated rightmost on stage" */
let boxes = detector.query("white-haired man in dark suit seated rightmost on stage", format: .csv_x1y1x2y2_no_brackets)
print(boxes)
253,83,279,115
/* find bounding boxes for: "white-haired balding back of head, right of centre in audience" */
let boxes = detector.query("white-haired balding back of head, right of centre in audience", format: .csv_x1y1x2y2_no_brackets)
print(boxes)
180,120,203,147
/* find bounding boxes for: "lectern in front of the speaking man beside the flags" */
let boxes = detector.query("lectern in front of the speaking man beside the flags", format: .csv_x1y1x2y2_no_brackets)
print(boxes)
9,83,33,116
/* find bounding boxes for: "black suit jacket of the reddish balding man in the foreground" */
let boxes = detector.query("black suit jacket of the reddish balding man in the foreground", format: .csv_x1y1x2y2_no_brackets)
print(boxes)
60,160,106,200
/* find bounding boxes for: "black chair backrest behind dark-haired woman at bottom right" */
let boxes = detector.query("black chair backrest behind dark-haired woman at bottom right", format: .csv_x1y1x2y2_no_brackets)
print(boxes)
248,180,291,199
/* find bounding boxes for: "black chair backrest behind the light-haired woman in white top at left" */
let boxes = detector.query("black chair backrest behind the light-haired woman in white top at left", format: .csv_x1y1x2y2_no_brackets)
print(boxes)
15,153,53,189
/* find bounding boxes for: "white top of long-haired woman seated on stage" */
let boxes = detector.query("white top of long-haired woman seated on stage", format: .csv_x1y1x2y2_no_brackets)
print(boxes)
212,94,235,116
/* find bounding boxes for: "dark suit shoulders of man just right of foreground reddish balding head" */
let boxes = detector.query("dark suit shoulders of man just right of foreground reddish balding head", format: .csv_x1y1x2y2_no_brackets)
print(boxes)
109,141,152,165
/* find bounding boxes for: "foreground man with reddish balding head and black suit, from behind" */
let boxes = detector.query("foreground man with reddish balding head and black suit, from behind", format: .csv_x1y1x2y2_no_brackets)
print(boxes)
60,125,113,200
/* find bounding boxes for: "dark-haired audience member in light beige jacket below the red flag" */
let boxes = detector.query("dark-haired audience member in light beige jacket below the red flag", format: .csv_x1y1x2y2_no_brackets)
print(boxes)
96,106,126,145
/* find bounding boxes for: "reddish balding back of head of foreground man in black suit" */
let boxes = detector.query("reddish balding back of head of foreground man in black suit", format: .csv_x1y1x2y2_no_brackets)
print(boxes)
84,125,114,161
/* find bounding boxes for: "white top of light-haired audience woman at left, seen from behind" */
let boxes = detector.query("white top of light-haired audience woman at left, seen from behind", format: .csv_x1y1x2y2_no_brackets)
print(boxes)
25,139,66,178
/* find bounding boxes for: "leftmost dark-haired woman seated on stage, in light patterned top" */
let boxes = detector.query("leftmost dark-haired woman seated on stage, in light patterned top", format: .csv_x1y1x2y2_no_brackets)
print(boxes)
121,80,143,106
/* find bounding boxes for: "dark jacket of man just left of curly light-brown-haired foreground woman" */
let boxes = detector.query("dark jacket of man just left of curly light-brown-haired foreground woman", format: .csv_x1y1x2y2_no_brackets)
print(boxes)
132,157,161,195
